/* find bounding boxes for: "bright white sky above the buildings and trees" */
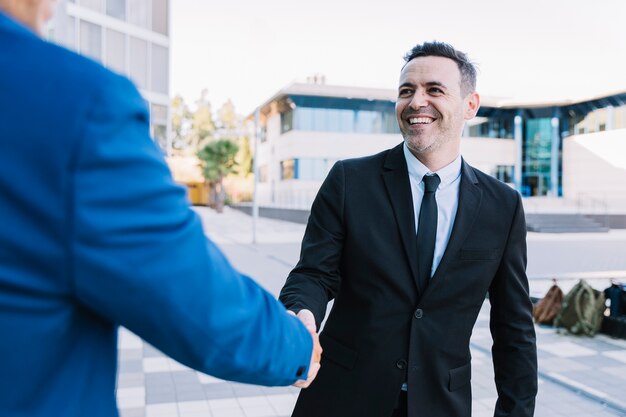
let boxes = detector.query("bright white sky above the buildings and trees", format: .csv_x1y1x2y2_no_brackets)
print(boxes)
170,0,626,116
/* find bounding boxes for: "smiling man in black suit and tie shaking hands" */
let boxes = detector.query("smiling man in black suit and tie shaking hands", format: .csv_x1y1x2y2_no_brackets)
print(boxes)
280,42,537,417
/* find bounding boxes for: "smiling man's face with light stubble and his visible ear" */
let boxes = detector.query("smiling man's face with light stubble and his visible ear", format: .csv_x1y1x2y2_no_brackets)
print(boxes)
396,56,478,159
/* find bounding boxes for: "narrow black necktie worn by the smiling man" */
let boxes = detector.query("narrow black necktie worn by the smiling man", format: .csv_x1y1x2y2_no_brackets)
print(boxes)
417,174,441,293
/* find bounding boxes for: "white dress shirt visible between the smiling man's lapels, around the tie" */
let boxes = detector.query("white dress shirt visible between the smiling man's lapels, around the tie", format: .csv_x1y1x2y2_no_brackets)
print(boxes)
403,143,461,277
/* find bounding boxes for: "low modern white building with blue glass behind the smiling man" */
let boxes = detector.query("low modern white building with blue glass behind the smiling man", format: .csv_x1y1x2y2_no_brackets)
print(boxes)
249,80,626,219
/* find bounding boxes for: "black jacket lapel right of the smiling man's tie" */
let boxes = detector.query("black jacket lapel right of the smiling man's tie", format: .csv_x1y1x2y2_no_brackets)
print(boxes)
428,161,482,289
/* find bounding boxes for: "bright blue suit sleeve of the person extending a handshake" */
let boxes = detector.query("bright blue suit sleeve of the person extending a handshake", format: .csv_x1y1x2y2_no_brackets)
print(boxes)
72,76,312,385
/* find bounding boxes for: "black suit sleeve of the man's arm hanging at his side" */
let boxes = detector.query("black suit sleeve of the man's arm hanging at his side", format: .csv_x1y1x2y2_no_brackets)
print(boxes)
489,194,537,417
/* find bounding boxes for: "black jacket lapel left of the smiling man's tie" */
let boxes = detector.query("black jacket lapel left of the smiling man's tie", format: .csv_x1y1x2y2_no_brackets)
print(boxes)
382,143,417,284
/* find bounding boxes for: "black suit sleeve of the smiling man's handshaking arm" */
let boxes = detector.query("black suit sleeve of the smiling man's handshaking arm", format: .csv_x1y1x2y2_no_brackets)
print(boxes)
279,161,345,329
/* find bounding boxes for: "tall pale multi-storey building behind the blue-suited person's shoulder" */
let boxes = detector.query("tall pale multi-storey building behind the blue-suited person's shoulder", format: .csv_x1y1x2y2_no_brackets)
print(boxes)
48,0,171,153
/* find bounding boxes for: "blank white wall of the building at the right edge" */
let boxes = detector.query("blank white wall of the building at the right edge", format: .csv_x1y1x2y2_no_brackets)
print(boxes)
563,129,626,213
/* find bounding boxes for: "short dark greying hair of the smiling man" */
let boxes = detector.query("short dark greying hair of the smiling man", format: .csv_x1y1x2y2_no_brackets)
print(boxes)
404,41,477,95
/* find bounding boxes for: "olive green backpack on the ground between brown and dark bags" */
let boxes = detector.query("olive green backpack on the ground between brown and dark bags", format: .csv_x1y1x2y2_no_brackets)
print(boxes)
554,279,606,336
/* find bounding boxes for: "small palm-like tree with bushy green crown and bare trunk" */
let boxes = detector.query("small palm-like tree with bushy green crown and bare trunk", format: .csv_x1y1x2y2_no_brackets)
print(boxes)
197,139,239,213
